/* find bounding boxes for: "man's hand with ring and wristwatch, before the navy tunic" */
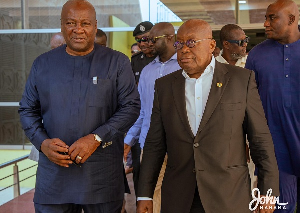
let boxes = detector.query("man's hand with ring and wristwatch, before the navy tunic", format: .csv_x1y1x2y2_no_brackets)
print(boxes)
69,134,100,163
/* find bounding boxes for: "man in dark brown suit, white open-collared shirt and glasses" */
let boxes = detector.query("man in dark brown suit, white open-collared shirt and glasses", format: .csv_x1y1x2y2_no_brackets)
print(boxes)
137,19,279,213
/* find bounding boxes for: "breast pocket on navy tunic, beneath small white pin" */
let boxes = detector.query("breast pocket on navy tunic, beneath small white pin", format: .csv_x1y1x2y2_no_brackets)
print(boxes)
89,79,114,107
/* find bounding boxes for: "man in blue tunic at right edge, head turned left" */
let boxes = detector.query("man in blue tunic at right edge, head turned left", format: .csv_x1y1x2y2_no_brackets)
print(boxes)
246,0,300,213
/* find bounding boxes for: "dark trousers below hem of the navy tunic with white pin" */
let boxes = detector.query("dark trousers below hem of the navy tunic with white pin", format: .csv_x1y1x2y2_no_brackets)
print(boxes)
34,200,123,213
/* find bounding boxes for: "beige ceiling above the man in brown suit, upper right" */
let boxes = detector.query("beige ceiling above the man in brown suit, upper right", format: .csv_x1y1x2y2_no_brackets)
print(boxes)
161,0,300,25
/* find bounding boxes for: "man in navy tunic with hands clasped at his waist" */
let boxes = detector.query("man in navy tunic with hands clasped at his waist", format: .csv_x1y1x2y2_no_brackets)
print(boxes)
19,0,140,213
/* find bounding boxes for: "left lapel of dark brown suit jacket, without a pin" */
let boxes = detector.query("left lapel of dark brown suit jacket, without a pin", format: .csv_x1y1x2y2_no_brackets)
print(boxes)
172,69,195,138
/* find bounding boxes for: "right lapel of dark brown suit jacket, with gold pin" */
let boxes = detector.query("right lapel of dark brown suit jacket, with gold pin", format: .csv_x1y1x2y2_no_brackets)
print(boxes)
197,61,231,136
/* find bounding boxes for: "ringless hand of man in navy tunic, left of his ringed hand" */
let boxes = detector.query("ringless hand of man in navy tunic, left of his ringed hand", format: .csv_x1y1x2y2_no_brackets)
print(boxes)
41,138,73,167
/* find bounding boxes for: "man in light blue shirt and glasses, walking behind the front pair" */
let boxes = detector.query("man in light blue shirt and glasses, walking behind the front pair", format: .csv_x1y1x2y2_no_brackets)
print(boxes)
124,22,180,213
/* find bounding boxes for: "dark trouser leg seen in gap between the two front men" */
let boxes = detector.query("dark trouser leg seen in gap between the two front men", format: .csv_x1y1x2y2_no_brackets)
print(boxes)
131,139,141,194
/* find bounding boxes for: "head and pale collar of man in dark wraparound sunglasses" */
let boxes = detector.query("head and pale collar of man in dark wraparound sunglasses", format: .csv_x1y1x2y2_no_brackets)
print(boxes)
216,24,250,67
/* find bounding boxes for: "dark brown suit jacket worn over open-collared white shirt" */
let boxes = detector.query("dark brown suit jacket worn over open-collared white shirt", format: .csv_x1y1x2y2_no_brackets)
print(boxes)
138,62,279,213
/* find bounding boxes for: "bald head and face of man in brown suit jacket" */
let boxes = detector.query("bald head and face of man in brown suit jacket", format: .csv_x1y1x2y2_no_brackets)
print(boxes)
177,19,216,78
